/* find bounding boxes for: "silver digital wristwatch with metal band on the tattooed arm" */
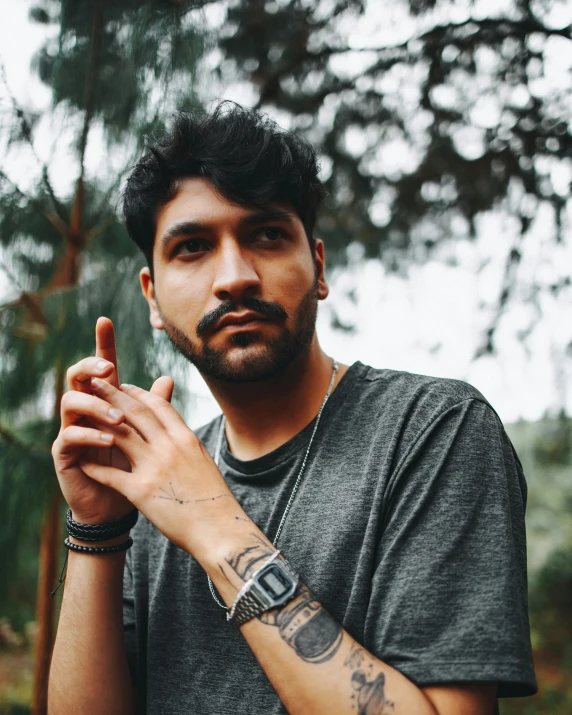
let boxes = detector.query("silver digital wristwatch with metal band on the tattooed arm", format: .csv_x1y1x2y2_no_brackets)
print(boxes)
226,550,299,626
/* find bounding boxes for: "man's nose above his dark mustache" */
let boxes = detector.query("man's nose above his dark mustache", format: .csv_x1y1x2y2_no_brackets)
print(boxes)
213,239,260,303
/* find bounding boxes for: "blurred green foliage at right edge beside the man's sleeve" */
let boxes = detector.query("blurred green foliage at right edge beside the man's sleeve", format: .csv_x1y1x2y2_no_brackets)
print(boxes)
500,414,572,715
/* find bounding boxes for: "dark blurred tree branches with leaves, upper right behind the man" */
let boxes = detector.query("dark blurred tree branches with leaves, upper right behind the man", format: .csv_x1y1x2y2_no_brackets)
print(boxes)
218,0,572,357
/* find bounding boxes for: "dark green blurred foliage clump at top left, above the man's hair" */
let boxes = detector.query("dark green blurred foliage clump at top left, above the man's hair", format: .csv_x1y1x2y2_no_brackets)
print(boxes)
31,0,204,142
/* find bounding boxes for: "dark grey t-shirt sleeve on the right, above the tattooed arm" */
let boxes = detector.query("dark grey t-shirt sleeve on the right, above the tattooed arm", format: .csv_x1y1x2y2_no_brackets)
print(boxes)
366,398,537,697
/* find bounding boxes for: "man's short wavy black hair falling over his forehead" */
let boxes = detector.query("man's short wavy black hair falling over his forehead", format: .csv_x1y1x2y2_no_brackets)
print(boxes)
123,100,326,275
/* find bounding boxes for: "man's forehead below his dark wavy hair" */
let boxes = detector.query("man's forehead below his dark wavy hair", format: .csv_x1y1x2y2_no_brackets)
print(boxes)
155,178,302,239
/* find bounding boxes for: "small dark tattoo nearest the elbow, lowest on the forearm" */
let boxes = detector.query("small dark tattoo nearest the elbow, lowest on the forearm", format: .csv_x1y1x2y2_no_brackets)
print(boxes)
344,642,394,715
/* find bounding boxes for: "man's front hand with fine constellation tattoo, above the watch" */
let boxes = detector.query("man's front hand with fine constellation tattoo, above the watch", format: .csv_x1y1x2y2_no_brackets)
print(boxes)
74,378,246,562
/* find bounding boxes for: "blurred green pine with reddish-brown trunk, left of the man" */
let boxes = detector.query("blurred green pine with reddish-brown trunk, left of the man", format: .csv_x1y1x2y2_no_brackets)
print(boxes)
0,0,206,715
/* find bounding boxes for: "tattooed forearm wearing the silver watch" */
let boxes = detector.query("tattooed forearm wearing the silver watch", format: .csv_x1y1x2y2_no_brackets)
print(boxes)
203,533,435,715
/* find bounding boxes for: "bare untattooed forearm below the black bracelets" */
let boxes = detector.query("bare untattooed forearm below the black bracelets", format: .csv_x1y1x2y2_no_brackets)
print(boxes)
48,535,135,715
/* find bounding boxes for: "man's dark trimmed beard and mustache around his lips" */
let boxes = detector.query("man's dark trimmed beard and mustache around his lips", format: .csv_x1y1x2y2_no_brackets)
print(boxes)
161,281,318,383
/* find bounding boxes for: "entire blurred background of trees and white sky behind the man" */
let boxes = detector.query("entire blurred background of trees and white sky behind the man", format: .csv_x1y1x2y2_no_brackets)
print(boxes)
0,0,572,715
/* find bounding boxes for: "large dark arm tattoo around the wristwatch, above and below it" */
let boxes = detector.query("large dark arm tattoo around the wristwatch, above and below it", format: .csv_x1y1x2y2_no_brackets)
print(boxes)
227,536,342,664
